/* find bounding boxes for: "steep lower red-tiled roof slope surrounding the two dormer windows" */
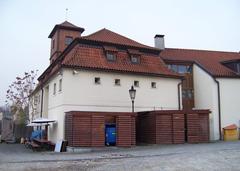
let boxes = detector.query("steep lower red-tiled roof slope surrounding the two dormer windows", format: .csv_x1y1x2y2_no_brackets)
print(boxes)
62,44,179,78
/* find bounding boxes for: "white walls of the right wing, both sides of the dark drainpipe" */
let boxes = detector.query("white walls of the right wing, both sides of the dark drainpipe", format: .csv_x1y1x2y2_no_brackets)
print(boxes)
193,65,240,140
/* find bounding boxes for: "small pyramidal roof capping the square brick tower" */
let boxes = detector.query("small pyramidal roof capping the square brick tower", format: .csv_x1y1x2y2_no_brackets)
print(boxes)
48,21,85,38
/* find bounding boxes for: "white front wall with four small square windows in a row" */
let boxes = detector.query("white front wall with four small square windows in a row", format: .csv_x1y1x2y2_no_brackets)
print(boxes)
63,70,180,112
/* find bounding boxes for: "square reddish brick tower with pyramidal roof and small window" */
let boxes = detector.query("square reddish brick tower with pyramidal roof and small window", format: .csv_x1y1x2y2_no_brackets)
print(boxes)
48,21,84,63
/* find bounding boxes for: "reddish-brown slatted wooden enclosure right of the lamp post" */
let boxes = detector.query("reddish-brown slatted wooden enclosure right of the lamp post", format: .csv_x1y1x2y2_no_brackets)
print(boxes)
136,110,210,144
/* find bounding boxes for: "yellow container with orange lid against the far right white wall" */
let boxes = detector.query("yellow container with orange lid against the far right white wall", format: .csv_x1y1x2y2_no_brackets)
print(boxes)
223,124,238,141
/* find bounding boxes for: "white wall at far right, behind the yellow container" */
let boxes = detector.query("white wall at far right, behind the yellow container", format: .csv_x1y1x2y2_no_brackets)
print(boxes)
217,78,240,127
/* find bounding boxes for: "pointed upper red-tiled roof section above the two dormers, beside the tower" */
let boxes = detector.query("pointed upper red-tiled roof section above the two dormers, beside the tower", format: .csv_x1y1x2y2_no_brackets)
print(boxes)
82,28,159,51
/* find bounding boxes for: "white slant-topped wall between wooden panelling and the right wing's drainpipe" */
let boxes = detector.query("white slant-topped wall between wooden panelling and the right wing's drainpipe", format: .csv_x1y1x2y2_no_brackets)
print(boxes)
193,64,219,140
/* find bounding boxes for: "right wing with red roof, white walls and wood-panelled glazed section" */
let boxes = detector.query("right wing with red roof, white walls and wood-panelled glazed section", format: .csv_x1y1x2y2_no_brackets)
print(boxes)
160,48,240,140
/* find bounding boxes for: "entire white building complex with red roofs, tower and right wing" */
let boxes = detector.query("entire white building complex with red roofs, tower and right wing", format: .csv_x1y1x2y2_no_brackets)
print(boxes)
30,21,240,146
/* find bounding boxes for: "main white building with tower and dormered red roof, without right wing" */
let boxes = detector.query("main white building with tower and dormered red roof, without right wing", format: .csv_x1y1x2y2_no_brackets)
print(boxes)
30,21,183,143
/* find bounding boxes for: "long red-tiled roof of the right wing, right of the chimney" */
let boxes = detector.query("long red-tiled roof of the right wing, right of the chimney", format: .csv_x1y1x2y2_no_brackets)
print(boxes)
160,48,240,77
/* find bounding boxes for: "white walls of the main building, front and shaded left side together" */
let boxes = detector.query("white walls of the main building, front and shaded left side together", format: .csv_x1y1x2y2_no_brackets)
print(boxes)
32,69,181,142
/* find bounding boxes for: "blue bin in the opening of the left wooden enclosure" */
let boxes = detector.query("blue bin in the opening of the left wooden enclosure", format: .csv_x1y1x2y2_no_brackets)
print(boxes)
105,124,116,145
